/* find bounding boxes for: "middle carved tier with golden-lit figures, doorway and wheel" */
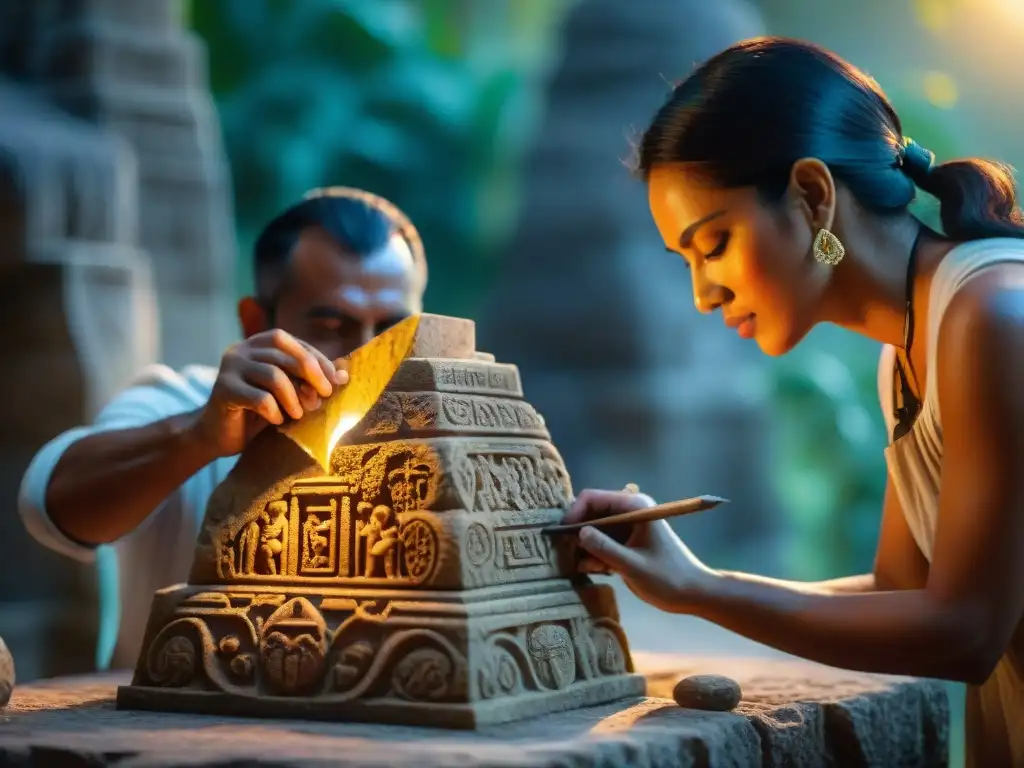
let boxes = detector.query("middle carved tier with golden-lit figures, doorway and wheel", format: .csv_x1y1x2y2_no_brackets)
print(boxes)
189,437,571,589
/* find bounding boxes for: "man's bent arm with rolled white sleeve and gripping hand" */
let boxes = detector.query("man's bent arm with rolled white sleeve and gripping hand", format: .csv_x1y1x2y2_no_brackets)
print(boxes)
19,330,347,557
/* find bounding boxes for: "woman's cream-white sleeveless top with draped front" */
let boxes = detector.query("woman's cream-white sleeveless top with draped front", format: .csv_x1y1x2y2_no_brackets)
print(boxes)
879,238,1024,562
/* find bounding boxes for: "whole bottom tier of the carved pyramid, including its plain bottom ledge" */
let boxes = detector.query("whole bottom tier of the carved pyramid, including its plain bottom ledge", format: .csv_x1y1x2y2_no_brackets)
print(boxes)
117,580,645,729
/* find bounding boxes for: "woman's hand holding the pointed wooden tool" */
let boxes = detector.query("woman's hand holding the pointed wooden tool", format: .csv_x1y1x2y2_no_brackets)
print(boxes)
564,488,712,613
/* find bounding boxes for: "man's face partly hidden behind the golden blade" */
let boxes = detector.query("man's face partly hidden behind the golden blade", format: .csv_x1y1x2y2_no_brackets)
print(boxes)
253,227,426,359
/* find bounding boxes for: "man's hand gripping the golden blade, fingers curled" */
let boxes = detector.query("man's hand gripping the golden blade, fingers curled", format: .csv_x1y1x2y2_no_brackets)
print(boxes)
196,329,348,457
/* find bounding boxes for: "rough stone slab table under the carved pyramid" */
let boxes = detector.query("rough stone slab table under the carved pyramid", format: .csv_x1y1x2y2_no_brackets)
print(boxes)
0,653,949,768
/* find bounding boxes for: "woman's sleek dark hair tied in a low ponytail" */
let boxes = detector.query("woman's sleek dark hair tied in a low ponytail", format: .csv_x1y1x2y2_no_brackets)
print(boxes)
636,37,1024,241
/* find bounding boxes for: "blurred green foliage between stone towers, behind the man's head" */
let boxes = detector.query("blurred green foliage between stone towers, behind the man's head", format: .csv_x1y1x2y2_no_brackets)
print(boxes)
186,0,570,314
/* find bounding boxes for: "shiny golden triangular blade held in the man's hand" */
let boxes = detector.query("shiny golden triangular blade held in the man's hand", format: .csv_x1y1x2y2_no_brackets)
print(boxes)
278,314,420,474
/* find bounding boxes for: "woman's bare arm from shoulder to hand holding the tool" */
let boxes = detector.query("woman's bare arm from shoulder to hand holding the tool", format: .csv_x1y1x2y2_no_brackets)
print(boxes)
577,278,1024,683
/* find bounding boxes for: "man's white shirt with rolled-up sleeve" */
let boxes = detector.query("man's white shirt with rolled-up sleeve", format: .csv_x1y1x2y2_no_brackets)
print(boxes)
17,366,237,669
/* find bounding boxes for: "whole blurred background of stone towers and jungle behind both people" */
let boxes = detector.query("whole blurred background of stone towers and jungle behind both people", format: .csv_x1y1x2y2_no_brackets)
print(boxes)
0,0,1024,765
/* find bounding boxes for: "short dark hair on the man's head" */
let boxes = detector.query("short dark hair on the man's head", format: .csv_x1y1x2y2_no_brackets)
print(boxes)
253,186,427,313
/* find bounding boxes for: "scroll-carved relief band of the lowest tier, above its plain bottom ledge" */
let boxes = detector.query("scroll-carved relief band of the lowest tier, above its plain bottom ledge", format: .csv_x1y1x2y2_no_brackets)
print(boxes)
121,586,642,719
